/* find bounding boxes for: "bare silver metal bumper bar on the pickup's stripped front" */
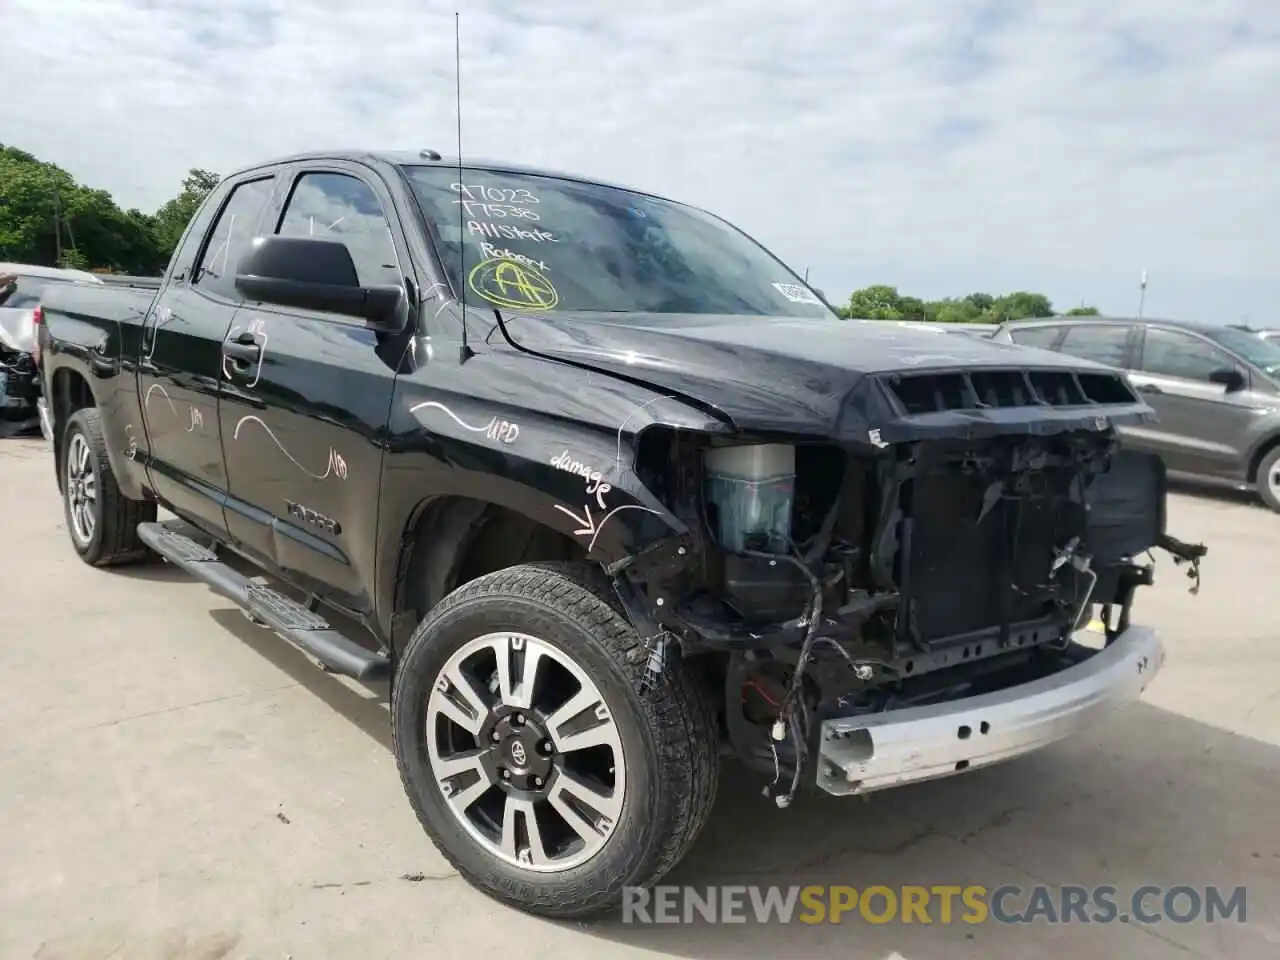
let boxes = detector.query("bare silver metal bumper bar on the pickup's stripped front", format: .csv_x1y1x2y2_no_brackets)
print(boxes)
818,627,1165,796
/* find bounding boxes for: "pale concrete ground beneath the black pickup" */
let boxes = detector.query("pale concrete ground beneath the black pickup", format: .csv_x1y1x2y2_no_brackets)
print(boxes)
0,440,1280,960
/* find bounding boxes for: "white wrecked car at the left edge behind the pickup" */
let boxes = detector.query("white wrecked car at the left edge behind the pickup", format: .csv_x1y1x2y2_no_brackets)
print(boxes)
0,264,100,436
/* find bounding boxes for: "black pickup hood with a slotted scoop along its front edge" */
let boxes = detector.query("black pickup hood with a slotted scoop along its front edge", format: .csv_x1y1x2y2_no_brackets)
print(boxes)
490,312,1153,447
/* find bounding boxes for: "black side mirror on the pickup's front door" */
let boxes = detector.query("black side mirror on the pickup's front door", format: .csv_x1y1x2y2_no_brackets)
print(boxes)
236,236,407,333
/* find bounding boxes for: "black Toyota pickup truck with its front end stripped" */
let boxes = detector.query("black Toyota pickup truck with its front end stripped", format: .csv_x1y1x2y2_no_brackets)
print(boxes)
38,151,1203,916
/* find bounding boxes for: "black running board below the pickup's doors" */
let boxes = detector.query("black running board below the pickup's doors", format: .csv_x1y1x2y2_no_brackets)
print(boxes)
138,520,390,680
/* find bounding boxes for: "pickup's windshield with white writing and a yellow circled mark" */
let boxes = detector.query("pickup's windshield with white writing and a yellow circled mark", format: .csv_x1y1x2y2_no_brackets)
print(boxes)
404,166,835,317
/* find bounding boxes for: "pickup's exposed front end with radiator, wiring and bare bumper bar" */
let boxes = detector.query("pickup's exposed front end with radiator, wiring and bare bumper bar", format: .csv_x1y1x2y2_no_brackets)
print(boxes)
611,370,1204,806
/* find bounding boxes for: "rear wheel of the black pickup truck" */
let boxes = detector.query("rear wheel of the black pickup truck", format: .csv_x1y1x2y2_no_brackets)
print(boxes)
61,407,156,567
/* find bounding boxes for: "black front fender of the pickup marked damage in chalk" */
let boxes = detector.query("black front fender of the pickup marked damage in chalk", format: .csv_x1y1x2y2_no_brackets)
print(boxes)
378,355,726,642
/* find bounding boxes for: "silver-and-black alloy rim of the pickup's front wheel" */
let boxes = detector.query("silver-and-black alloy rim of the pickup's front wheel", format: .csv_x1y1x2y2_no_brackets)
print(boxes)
425,632,626,873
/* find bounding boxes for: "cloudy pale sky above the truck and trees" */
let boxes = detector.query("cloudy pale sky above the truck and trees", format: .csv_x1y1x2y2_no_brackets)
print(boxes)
0,0,1280,324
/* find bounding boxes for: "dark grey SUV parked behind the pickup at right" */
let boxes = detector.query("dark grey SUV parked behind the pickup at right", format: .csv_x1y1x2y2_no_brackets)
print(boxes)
993,317,1280,512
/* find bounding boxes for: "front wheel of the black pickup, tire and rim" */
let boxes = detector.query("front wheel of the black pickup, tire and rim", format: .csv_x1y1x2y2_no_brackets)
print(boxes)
392,563,718,918
